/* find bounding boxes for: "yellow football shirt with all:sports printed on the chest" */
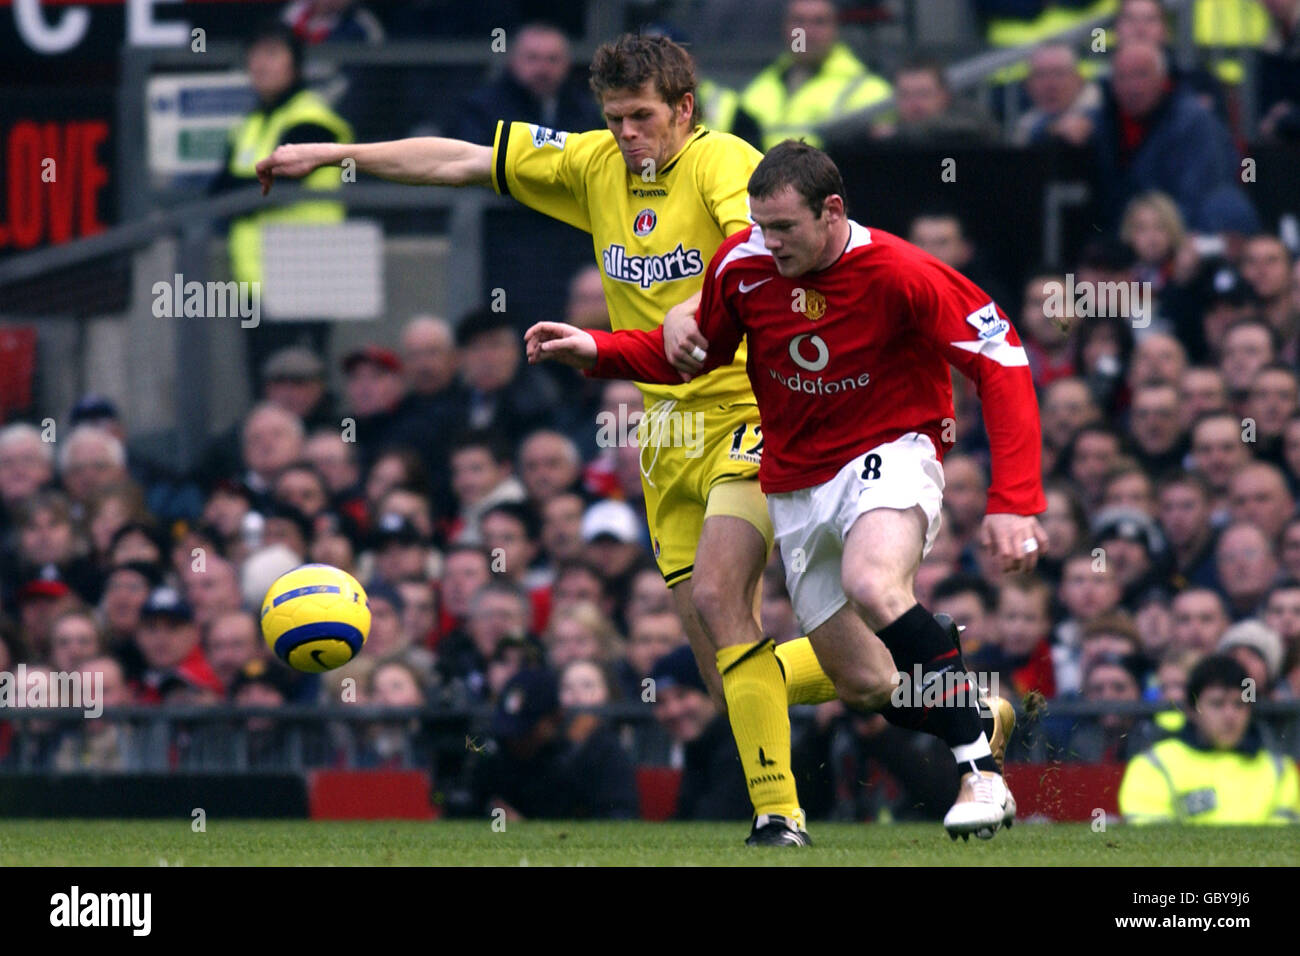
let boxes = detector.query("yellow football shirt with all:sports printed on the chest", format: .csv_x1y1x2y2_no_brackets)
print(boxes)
491,121,762,407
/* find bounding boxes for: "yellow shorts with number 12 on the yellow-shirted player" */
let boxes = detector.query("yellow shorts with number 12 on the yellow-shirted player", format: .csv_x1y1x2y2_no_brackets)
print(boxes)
637,399,772,587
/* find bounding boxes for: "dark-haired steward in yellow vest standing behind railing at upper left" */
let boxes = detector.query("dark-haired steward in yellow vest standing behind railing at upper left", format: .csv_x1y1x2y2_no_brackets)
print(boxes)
208,25,352,282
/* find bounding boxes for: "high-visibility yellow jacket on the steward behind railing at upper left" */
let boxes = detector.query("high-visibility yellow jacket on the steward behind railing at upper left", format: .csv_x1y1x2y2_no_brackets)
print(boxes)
228,90,352,282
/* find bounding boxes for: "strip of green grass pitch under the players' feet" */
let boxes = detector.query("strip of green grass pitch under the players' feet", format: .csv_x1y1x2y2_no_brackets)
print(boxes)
0,818,1300,866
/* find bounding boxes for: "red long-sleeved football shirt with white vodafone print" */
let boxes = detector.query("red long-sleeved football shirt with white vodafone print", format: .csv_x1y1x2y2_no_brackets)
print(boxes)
592,221,1047,515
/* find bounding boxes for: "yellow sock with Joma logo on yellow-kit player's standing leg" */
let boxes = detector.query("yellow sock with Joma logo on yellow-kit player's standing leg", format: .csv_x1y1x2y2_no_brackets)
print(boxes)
718,640,800,818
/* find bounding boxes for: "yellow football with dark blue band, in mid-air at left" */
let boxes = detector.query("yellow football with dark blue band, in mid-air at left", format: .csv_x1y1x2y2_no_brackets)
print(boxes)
261,564,371,674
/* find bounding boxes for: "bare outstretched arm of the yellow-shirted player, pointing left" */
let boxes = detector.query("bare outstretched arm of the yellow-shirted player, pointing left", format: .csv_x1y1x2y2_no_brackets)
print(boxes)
257,137,491,195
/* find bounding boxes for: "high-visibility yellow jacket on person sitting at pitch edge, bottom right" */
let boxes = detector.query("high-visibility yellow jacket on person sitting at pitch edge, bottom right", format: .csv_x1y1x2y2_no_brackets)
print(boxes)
1119,724,1300,825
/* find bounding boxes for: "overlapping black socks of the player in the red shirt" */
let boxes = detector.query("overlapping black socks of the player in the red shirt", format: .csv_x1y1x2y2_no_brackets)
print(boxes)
876,604,997,771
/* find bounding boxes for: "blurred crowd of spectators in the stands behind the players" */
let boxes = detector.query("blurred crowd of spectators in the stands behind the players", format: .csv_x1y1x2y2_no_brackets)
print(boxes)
0,0,1300,818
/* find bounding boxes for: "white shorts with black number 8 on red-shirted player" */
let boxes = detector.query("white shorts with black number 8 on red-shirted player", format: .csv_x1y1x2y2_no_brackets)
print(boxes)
767,432,944,633
